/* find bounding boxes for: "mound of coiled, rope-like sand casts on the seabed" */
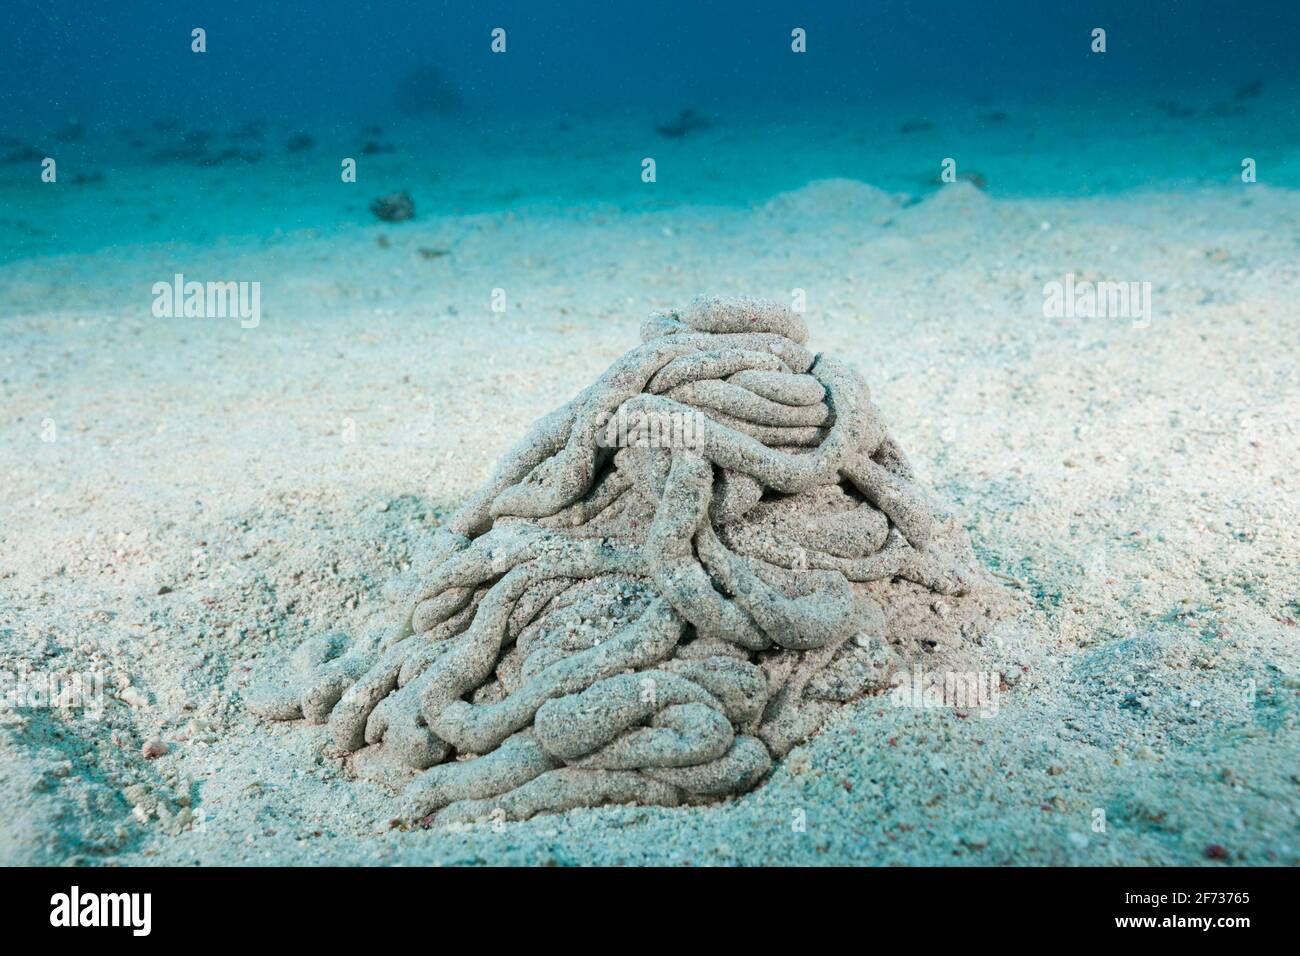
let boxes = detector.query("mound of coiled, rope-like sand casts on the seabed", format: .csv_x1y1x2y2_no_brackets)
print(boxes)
248,299,997,823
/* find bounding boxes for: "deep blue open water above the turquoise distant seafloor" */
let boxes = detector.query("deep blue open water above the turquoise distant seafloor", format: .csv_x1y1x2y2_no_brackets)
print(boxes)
0,0,1300,131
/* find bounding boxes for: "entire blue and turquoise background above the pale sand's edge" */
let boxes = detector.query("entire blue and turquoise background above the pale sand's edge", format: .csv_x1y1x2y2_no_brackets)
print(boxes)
0,0,1300,258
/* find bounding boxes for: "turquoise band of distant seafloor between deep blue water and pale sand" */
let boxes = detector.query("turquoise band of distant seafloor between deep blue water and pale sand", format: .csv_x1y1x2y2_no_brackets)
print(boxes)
0,85,1300,261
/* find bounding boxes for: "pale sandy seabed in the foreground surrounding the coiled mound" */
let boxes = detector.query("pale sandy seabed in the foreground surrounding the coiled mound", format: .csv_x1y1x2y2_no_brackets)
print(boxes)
0,174,1300,865
